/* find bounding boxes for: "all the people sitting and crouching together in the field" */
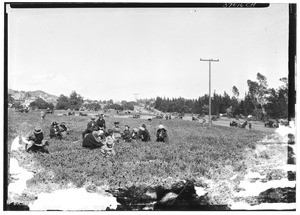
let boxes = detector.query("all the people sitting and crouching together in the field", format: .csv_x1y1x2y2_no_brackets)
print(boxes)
24,114,169,156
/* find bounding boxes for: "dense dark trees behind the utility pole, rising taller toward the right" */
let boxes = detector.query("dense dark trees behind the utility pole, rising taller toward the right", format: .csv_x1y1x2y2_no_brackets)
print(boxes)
154,73,288,120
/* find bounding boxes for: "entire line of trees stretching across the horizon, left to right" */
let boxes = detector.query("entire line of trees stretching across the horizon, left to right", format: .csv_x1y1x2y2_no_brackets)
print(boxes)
8,73,288,120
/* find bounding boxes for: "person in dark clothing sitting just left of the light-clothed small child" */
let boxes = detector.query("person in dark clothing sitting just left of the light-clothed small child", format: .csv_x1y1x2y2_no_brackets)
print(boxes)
82,130,105,149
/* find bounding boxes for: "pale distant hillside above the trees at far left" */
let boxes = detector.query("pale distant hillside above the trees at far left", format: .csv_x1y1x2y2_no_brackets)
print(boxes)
8,89,58,104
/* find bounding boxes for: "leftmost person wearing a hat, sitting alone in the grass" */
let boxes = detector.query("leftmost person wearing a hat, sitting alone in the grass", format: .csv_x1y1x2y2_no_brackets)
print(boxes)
25,126,49,153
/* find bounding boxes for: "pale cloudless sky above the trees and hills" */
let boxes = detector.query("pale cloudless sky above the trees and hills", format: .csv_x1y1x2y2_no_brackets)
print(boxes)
8,4,288,100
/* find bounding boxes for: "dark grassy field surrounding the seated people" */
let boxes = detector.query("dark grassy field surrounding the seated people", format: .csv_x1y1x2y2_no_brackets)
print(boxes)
8,111,265,203
